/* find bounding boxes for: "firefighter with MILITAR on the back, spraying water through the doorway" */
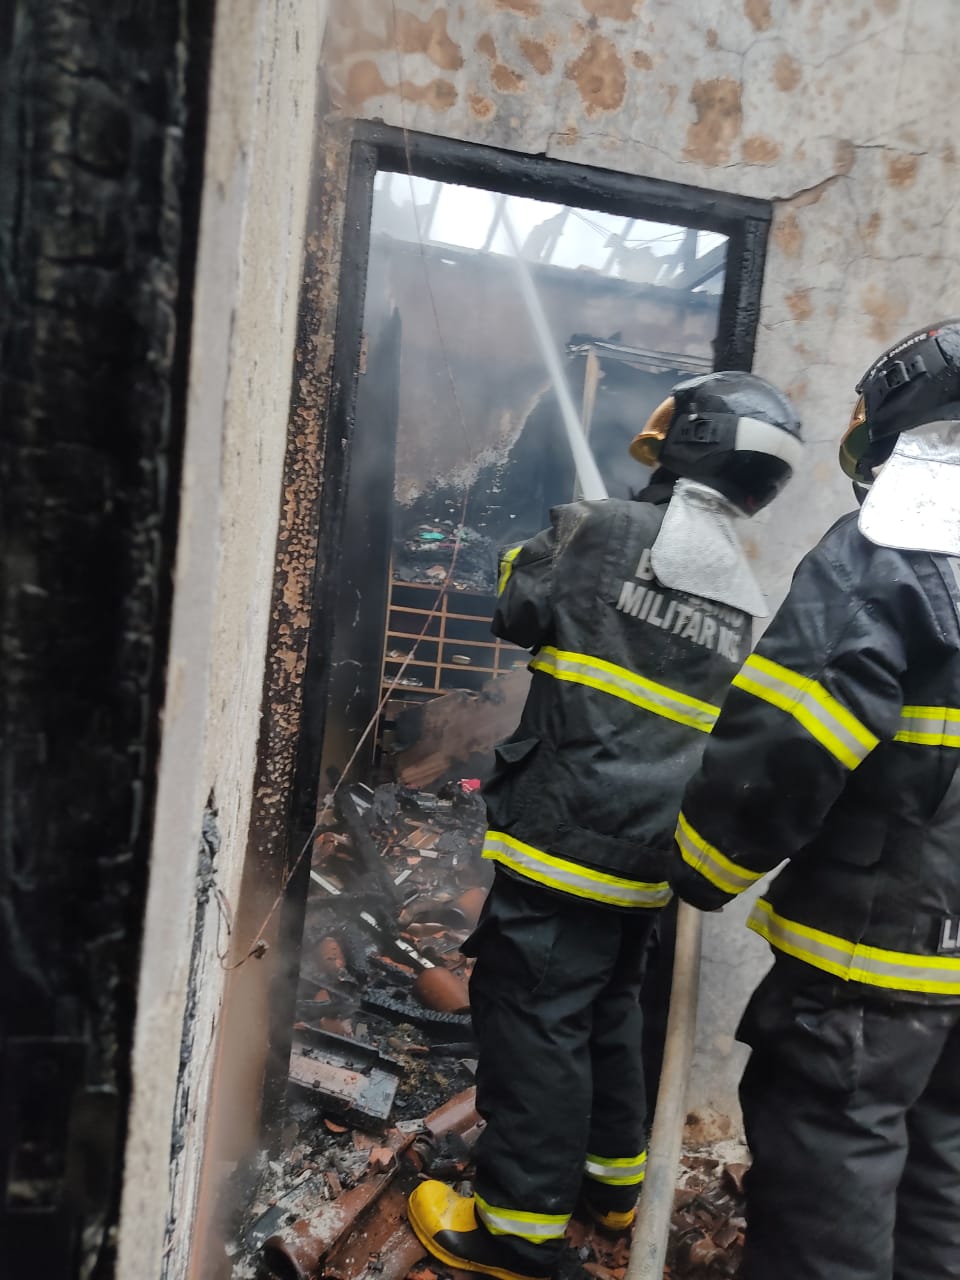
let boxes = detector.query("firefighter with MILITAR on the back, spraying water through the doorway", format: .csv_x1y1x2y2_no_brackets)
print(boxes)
410,372,801,1280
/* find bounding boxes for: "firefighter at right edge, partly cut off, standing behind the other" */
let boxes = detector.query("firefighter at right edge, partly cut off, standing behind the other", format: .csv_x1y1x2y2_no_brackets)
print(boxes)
675,320,960,1280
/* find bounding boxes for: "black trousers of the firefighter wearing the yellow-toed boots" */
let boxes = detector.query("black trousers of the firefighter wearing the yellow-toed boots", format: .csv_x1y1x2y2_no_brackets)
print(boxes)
463,870,655,1274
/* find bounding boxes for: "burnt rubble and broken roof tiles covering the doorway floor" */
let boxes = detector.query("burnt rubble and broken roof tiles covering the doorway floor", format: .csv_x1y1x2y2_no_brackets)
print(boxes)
229,778,744,1280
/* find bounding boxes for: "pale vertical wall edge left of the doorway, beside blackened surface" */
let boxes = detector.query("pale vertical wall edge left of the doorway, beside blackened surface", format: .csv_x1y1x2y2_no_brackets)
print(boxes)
118,0,325,1277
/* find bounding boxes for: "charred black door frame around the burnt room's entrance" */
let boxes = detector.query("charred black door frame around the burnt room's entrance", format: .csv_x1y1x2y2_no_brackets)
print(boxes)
262,122,772,1139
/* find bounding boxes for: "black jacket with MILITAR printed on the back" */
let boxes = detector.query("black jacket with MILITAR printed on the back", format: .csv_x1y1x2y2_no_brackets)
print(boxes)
484,490,751,908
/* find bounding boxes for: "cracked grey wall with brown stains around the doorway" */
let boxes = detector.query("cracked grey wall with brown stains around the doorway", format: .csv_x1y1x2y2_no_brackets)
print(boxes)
326,0,960,1128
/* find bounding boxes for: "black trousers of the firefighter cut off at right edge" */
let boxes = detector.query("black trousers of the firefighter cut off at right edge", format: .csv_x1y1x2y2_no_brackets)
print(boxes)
739,964,960,1280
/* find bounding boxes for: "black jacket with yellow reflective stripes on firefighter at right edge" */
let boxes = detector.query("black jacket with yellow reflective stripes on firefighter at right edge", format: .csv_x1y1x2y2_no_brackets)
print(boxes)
675,515,960,1001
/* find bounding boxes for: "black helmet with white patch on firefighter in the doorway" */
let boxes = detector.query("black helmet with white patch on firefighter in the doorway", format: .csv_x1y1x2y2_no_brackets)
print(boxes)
630,371,803,516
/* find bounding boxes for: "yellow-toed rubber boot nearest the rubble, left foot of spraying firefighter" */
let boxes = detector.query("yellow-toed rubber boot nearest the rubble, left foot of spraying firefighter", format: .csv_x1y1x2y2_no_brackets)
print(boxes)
407,1181,552,1280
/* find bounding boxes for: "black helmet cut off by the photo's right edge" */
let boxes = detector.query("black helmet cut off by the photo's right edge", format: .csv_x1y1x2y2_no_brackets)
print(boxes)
840,320,960,484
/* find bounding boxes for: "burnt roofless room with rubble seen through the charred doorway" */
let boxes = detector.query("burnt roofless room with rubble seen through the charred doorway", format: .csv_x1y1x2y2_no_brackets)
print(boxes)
232,129,773,1280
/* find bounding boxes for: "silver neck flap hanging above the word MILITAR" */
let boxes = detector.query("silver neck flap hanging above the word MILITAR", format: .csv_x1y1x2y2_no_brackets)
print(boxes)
650,480,767,618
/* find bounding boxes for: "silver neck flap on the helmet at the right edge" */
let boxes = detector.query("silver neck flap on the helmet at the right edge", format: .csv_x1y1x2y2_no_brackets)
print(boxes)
859,422,960,556
